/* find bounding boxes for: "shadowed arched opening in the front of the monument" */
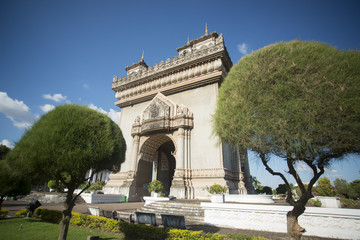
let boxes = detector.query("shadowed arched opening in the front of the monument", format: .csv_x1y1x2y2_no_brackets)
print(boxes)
135,134,176,199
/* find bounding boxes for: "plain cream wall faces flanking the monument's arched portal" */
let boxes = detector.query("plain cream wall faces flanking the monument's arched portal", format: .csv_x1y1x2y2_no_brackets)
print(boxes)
119,83,222,172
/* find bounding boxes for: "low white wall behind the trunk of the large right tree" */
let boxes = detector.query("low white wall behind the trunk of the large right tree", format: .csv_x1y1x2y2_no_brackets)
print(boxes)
201,203,360,239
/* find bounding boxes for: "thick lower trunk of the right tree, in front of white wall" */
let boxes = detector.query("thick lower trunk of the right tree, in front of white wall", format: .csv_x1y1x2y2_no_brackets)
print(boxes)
286,206,305,240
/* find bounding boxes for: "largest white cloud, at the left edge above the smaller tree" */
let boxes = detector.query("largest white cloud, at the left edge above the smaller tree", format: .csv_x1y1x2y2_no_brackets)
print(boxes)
0,92,36,128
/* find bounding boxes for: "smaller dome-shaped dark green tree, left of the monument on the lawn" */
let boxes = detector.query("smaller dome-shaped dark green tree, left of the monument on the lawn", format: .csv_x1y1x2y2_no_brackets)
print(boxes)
8,105,126,240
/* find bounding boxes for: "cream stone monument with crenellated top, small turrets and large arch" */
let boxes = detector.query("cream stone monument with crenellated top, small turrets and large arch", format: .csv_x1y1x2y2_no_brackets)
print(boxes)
105,30,251,201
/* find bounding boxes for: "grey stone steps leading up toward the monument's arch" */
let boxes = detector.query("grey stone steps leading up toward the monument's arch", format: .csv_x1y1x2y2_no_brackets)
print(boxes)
138,200,204,225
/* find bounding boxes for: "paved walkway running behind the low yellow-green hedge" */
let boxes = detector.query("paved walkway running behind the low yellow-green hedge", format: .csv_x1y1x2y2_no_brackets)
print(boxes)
2,201,335,240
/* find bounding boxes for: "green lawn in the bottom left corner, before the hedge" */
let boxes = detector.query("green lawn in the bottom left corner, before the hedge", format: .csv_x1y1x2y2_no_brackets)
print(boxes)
0,218,123,240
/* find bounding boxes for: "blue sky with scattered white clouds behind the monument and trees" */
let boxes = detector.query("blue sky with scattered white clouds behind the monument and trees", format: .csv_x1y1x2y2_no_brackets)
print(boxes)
0,0,360,187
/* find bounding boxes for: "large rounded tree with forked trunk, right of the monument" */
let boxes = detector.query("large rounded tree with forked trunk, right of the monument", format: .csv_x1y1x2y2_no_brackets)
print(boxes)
214,41,360,239
